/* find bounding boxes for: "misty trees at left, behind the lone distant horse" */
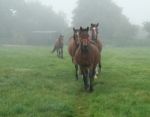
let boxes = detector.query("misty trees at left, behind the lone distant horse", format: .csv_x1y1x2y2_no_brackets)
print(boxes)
0,0,68,44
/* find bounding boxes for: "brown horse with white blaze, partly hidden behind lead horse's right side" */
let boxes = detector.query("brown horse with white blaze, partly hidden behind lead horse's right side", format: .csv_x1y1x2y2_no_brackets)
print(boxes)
90,23,102,72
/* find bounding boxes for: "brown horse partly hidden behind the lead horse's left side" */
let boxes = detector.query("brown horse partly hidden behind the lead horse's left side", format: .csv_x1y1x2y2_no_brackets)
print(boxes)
68,28,79,80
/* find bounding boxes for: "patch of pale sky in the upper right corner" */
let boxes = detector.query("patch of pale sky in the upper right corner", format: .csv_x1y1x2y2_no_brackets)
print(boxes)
113,0,150,25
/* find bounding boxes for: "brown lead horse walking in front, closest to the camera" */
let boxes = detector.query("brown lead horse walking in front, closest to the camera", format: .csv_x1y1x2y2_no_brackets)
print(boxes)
74,27,99,91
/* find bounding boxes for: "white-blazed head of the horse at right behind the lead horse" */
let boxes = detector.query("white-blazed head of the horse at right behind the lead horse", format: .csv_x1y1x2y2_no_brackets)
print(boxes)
90,23,99,41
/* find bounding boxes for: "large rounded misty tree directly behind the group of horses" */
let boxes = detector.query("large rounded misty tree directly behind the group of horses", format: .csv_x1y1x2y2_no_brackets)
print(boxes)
73,0,137,43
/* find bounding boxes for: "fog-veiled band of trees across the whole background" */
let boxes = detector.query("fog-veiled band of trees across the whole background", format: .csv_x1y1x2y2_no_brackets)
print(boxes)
0,0,150,46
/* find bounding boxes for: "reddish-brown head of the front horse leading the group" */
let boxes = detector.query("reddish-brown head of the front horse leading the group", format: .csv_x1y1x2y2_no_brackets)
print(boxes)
79,27,90,52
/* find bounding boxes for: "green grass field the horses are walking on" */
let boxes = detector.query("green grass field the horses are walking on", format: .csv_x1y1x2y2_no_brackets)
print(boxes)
0,46,150,117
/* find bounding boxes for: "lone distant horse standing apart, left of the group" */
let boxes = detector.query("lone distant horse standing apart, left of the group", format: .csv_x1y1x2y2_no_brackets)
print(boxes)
52,35,64,58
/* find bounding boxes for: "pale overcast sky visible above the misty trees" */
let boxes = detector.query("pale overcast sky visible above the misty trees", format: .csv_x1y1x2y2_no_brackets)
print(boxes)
29,0,150,25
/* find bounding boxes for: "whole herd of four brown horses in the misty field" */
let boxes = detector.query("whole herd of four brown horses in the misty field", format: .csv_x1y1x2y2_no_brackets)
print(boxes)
52,23,102,92
